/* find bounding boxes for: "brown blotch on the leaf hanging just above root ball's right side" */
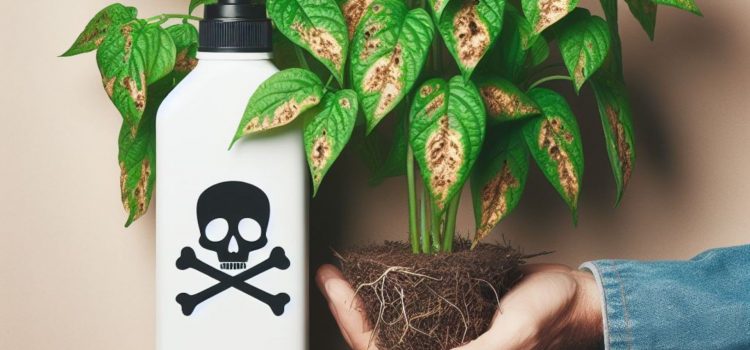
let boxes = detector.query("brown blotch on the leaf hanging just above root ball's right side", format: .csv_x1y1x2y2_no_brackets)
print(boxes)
474,161,521,244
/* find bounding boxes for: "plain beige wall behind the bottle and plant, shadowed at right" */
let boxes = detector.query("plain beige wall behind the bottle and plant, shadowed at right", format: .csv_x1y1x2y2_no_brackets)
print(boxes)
0,0,750,350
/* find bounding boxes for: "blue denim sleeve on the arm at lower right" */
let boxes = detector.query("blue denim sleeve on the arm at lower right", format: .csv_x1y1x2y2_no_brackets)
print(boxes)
581,245,750,350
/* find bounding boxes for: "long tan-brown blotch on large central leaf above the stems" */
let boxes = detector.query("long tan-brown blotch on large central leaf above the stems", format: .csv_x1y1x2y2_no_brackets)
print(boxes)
425,116,465,208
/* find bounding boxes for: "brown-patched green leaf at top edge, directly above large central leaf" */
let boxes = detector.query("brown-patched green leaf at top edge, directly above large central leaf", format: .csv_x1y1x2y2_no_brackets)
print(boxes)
438,0,505,79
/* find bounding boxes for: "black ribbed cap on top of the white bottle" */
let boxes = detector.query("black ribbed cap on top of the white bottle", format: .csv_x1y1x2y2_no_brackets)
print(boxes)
198,0,273,52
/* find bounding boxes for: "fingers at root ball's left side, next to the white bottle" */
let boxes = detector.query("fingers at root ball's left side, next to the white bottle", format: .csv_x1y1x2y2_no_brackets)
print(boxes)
315,265,375,350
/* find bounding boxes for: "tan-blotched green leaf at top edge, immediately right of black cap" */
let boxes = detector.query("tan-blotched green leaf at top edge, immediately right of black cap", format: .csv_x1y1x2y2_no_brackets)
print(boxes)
266,0,349,83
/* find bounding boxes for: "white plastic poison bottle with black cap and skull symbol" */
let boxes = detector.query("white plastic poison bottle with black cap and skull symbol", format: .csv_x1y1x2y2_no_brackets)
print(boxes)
156,0,308,350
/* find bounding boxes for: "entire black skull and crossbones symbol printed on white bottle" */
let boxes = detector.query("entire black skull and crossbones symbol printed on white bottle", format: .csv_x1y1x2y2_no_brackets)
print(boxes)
176,181,291,316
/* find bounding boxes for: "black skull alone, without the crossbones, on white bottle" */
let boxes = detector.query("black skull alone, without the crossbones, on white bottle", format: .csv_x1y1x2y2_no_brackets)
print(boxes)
197,181,271,270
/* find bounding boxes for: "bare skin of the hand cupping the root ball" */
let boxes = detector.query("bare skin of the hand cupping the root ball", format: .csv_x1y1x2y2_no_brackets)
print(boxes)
316,264,603,350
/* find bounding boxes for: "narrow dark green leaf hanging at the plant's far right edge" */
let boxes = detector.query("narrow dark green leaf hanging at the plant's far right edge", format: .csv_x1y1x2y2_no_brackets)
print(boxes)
591,74,635,205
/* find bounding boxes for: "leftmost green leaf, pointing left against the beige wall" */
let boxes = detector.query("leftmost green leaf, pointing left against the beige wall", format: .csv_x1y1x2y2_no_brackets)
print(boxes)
61,4,138,57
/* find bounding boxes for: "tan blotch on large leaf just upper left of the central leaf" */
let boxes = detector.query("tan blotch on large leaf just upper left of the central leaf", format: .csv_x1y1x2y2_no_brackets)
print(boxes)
362,45,404,120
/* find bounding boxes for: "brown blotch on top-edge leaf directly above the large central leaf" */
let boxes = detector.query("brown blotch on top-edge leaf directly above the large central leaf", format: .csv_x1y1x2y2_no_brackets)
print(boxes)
453,0,490,68
